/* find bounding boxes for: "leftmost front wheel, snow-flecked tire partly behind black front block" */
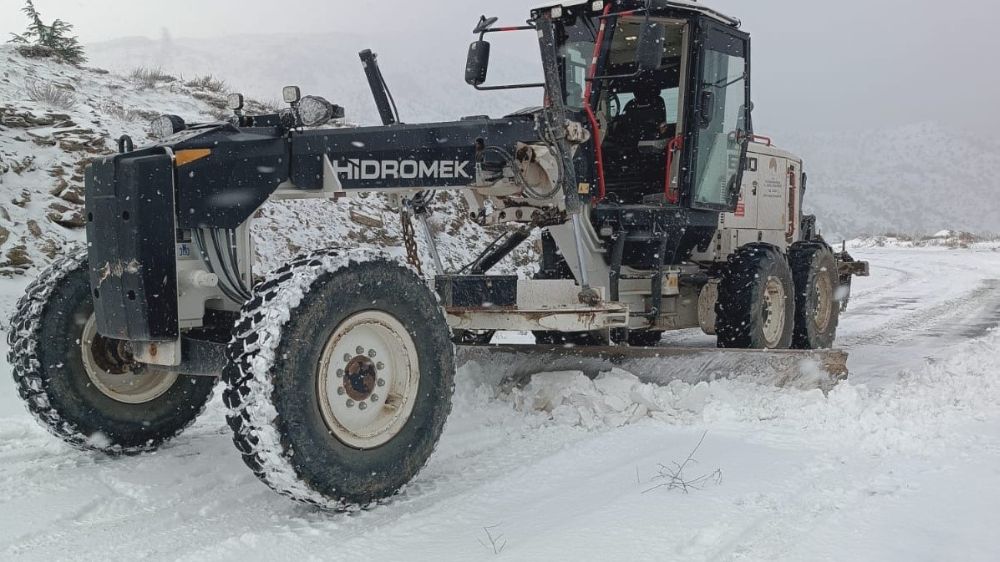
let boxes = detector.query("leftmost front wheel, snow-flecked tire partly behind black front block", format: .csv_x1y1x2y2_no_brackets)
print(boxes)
8,250,216,454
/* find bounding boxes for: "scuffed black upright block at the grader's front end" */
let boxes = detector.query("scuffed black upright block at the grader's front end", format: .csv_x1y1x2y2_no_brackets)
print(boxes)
86,154,179,341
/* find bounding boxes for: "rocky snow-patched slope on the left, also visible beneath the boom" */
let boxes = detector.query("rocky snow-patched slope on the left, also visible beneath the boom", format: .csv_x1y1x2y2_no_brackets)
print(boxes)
0,46,535,276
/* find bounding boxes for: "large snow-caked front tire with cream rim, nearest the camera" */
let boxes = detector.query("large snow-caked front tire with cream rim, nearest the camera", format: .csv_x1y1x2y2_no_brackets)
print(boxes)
224,250,455,511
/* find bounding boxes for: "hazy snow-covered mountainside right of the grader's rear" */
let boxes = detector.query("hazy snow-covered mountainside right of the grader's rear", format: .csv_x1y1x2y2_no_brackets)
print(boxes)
780,123,1000,236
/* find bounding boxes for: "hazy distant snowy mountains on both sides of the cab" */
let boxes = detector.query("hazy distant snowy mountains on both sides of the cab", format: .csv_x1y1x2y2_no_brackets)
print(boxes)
89,33,1000,240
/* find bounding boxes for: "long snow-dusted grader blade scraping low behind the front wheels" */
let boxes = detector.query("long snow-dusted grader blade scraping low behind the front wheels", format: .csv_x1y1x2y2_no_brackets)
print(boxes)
458,345,847,392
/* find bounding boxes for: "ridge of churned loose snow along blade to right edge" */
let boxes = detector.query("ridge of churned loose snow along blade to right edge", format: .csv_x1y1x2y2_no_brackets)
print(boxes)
506,330,1000,454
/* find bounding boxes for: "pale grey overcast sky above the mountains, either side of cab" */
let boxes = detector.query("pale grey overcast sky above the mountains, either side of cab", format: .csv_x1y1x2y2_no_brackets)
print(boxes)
0,0,1000,132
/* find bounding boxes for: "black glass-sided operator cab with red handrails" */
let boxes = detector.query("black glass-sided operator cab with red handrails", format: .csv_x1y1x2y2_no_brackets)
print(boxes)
556,0,751,211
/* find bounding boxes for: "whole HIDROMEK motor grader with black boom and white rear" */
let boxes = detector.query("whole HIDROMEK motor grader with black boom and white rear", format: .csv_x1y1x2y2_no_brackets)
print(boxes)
9,0,867,510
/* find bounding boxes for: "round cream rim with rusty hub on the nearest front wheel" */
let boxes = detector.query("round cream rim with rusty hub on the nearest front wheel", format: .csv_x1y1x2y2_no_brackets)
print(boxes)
318,311,420,449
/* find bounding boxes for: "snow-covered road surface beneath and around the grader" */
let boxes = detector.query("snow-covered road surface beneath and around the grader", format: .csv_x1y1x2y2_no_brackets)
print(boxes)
0,249,1000,561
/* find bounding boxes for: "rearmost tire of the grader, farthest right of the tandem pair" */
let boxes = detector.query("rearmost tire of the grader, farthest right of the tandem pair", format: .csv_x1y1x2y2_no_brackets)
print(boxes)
791,243,840,349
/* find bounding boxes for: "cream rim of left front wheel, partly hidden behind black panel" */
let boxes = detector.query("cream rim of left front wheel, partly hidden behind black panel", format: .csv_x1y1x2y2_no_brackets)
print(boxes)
80,314,177,404
